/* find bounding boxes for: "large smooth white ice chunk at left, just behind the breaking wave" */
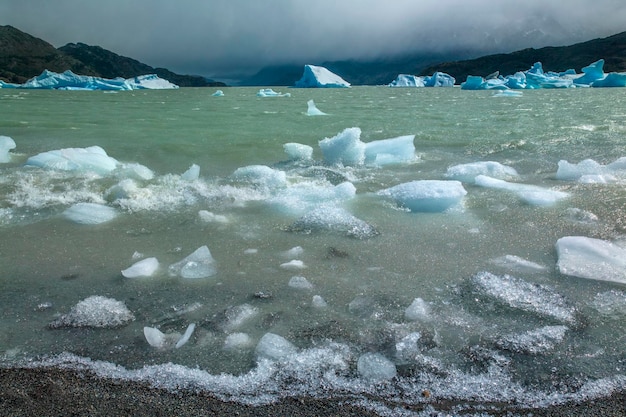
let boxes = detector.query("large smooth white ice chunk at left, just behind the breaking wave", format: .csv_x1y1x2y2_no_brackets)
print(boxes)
26,146,118,175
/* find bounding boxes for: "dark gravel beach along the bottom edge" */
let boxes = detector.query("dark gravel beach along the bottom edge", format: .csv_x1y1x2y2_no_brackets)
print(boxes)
0,368,626,417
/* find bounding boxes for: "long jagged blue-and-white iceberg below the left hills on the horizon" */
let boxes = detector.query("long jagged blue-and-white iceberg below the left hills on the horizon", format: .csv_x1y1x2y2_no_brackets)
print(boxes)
2,70,178,91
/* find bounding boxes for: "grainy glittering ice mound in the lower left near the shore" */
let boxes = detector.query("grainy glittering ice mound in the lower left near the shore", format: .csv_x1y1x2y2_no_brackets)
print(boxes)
50,295,135,329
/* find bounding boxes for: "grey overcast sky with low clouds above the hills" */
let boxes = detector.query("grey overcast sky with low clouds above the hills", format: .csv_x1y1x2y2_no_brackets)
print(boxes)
0,0,626,77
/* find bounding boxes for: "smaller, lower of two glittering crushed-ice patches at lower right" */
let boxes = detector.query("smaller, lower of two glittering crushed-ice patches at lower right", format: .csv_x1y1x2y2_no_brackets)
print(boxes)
496,326,569,355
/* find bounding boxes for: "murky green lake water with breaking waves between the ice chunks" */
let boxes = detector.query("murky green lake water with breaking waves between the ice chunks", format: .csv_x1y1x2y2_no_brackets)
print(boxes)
0,87,626,410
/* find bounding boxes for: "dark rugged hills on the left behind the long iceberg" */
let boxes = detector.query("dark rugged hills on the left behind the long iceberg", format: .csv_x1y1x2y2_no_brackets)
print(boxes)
0,26,225,87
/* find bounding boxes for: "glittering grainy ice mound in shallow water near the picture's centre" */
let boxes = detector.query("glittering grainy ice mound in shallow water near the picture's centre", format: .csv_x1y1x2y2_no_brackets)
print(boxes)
288,206,378,239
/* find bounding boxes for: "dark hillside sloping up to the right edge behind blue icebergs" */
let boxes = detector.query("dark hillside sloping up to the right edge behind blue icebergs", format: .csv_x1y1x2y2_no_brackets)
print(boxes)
415,32,626,83
